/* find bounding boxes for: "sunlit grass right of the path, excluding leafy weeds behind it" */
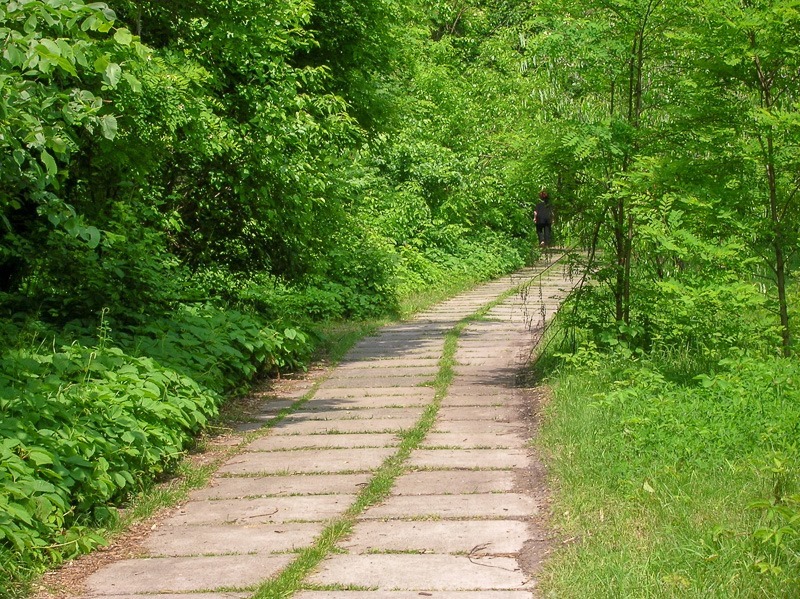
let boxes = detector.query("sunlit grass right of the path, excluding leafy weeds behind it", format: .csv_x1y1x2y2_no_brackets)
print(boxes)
536,352,800,599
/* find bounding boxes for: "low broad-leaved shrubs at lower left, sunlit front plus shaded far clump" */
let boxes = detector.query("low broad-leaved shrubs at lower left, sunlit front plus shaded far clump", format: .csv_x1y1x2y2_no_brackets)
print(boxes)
0,305,311,592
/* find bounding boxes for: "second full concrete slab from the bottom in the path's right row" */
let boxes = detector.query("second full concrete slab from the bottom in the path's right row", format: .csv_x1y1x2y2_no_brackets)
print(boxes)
340,520,528,555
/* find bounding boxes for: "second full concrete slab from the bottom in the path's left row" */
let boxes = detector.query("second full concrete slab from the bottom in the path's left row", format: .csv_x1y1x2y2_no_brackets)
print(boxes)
143,522,325,557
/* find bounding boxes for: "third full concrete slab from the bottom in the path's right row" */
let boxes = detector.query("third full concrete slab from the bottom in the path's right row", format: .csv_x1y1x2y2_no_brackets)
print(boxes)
360,493,539,520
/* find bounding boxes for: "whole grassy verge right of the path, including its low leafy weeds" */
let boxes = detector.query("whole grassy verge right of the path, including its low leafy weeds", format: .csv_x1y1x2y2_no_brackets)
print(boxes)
537,344,800,599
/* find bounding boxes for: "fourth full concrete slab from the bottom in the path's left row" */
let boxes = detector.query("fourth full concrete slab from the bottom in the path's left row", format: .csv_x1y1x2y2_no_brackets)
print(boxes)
189,472,370,501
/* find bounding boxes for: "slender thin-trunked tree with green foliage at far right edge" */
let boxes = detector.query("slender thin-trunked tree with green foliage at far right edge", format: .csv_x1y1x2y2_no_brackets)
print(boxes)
692,0,800,355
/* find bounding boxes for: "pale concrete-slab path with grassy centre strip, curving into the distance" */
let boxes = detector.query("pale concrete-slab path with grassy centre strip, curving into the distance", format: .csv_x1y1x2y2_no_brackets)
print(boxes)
76,252,577,599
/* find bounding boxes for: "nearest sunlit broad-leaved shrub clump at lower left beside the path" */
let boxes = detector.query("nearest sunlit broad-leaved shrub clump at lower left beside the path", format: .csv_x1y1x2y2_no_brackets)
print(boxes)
0,344,221,578
